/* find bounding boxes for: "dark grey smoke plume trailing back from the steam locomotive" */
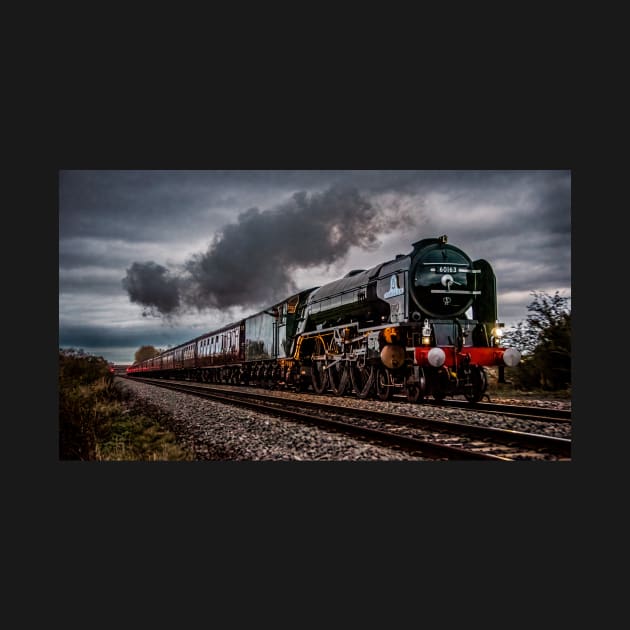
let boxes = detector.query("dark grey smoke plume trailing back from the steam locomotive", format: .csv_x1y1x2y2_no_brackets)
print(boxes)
122,186,414,317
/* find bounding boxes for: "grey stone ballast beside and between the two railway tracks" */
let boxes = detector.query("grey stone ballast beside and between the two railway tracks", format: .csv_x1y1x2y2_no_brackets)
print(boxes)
117,379,571,461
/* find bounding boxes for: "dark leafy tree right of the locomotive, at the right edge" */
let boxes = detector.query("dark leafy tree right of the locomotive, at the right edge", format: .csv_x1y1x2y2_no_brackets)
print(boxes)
504,291,571,390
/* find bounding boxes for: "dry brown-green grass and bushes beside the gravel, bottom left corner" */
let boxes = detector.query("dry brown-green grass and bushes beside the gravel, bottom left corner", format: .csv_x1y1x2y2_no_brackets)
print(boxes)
59,349,194,461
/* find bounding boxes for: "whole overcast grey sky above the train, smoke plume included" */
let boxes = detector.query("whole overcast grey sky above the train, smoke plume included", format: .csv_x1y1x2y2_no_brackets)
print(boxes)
59,170,571,363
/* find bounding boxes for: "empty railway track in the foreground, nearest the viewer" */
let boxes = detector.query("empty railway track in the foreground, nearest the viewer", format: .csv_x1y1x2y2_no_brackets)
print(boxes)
122,377,571,461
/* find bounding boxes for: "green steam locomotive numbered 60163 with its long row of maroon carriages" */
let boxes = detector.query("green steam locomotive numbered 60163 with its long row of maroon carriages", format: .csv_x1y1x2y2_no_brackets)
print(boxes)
126,235,521,403
